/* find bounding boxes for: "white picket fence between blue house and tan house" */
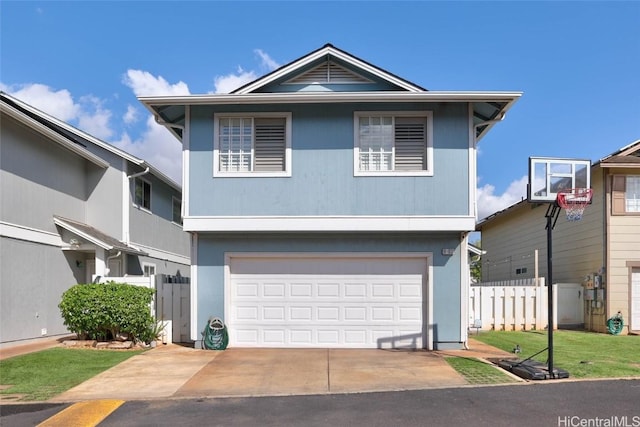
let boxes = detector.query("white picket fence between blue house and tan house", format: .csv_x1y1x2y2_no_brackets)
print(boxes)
469,278,558,331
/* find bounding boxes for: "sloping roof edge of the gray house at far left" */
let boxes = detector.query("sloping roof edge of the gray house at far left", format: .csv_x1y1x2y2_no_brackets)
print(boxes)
0,91,182,191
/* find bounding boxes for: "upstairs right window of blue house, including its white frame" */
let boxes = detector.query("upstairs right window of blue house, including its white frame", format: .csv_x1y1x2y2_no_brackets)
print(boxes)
354,111,433,176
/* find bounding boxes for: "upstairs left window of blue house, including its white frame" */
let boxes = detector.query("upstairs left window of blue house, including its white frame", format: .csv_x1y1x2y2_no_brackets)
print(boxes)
213,113,291,177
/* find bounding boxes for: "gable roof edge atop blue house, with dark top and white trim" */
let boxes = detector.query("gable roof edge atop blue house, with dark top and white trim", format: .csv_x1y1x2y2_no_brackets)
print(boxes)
231,43,426,94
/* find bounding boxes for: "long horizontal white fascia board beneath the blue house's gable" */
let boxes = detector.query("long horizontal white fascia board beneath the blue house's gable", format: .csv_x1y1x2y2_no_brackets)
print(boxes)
138,91,522,106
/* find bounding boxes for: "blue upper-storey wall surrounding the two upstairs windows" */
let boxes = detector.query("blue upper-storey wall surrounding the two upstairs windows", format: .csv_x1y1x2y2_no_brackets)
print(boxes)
189,104,470,216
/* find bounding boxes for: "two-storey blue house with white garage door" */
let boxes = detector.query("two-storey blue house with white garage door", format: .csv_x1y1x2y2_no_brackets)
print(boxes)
140,45,520,349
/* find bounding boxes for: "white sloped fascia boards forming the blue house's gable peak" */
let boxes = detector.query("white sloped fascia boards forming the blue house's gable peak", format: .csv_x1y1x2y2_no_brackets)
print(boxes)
235,47,423,95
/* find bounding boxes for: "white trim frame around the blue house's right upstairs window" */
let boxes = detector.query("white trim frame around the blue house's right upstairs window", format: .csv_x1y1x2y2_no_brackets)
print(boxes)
353,111,433,176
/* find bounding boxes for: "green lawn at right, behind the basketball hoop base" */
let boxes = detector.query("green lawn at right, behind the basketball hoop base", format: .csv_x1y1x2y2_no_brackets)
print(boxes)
473,330,640,378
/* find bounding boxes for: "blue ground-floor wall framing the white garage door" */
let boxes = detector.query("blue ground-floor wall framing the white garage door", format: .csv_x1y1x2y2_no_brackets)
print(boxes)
194,233,462,348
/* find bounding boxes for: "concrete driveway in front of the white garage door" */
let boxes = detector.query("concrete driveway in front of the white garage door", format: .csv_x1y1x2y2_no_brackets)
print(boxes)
51,344,467,402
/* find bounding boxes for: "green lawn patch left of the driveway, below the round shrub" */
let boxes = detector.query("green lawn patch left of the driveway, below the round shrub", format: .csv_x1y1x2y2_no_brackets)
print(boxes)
0,348,144,401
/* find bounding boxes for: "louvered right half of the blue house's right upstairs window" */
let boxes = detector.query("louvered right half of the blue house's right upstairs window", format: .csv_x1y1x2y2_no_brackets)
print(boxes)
394,117,427,171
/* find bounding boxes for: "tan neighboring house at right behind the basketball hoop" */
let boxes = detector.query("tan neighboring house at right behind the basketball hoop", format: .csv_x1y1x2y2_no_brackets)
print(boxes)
477,140,640,333
